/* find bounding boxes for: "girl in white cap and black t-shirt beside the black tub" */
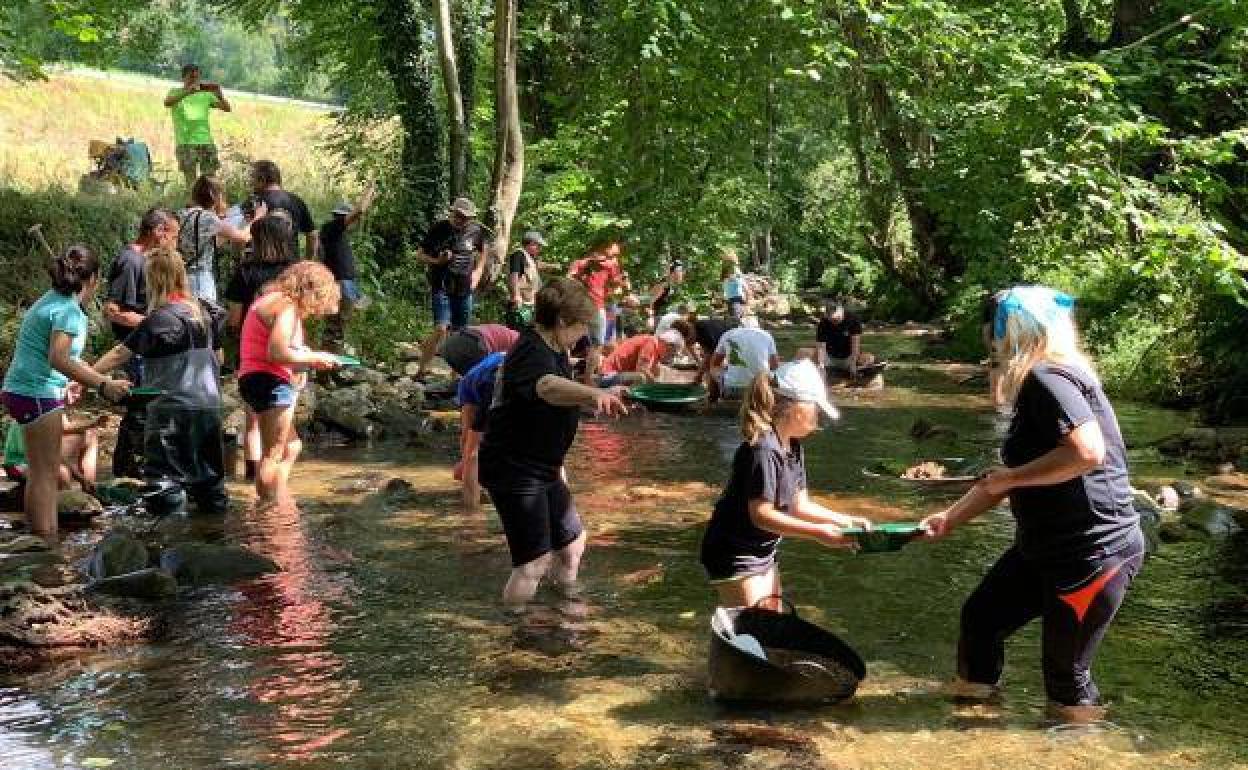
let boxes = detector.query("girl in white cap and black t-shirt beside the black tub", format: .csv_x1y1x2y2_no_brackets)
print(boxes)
701,361,871,608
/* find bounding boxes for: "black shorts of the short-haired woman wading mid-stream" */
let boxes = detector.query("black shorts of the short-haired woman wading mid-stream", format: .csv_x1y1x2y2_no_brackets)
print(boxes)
485,479,584,567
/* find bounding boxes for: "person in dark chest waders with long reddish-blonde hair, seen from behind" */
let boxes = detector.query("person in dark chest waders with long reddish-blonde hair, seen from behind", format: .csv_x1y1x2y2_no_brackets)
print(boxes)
95,248,228,513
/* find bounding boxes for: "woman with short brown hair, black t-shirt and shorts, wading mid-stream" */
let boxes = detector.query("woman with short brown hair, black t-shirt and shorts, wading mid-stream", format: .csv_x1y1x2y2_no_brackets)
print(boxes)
478,280,628,609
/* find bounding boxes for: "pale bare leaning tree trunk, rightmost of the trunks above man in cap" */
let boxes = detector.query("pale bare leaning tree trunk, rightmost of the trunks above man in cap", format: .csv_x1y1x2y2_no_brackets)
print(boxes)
490,0,524,261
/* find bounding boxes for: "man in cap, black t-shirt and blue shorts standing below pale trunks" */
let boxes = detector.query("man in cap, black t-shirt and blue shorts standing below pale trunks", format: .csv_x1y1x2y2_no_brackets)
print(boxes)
416,197,485,377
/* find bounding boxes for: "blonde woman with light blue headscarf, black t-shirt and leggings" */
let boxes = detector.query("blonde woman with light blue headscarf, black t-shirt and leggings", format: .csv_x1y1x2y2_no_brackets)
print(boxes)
924,286,1144,721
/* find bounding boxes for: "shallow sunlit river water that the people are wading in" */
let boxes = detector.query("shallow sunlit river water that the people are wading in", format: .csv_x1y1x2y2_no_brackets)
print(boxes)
0,331,1248,770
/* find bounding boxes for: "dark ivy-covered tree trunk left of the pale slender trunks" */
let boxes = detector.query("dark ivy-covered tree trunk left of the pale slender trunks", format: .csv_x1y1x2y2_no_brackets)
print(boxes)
377,0,447,239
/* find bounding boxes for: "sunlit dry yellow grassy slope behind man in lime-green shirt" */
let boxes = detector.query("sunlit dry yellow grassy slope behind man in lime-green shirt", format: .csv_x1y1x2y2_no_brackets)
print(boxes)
0,71,336,207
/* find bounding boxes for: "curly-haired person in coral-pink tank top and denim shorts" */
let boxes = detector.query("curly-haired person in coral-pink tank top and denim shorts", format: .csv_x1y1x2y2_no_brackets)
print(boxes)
238,262,339,502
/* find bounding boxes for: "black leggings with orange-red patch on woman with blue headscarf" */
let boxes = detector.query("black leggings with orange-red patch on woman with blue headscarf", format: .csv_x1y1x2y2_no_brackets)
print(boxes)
957,532,1144,706
